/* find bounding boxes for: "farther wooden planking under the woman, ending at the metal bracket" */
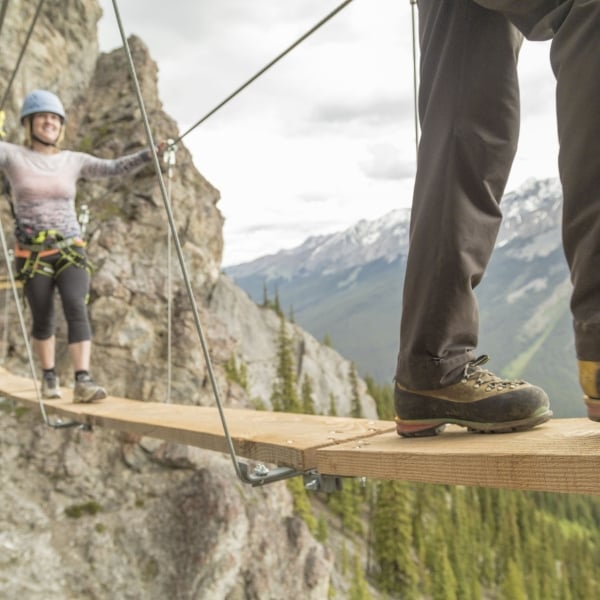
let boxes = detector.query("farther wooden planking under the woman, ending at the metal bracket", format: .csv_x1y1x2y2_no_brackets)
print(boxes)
0,368,395,471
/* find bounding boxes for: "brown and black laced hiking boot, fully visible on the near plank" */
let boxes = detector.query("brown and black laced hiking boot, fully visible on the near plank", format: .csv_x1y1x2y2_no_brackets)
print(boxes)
394,356,552,437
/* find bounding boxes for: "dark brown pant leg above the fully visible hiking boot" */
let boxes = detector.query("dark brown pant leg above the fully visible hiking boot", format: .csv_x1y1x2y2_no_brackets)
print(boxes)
396,0,522,389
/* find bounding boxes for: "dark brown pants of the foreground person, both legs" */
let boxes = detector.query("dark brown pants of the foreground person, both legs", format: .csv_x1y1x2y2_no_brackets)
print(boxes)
396,0,600,389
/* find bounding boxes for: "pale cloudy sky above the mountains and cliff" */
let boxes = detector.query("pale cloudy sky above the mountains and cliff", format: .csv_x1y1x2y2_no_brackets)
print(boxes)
98,0,558,266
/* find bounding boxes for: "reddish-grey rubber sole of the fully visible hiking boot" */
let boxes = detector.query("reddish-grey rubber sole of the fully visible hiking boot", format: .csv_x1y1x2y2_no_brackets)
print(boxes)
396,407,552,437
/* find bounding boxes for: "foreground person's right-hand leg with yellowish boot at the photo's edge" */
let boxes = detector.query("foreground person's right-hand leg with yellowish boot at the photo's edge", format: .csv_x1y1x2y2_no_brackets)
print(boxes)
475,0,600,421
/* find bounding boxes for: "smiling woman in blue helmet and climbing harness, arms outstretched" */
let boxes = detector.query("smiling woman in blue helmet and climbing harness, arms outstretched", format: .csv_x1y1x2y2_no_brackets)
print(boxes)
0,90,157,402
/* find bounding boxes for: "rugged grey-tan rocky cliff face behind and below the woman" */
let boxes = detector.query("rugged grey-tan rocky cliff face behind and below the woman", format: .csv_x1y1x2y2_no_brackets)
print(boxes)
0,0,375,600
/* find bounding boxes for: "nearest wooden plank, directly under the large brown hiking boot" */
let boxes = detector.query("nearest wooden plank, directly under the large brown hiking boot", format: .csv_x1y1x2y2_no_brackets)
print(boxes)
317,419,600,494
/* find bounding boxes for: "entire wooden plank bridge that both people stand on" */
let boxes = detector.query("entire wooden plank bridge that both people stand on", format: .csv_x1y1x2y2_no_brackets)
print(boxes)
0,368,600,494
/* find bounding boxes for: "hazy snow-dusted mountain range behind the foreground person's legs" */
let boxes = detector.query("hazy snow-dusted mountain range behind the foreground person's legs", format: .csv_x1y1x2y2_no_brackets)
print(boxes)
226,179,584,417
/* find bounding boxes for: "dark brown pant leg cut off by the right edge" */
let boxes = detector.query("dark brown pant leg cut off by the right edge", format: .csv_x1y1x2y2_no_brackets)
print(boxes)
550,0,600,361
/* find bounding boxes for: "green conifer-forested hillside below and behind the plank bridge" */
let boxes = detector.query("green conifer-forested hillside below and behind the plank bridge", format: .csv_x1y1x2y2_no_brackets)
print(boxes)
273,307,600,600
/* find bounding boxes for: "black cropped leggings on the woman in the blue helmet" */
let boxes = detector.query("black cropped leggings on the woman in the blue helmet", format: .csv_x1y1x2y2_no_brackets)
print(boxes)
15,248,92,344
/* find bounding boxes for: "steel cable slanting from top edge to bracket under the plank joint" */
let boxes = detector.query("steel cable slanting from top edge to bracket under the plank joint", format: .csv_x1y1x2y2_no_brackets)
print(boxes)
112,0,244,480
